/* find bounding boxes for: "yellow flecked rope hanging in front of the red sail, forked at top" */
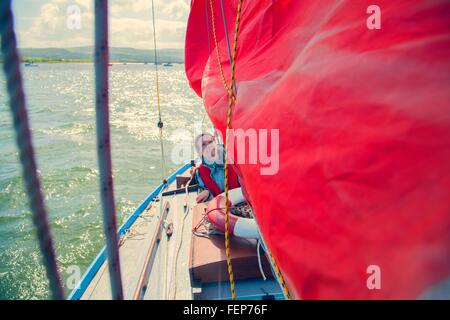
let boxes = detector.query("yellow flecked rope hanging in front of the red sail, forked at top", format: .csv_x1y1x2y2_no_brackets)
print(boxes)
209,0,292,300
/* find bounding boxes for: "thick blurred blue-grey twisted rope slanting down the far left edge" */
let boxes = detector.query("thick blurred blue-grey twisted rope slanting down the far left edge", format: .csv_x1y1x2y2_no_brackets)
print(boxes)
0,0,64,300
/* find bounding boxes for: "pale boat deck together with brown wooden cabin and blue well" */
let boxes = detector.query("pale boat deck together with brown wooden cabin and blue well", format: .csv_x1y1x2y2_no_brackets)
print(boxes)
81,170,283,300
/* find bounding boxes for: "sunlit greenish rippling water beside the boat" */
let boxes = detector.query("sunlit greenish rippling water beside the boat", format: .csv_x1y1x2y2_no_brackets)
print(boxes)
0,64,208,299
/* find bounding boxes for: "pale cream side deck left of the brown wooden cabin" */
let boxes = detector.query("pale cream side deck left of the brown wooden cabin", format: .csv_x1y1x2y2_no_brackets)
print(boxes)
81,171,197,300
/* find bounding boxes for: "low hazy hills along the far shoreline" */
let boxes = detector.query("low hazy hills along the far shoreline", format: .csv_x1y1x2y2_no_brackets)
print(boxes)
19,47,184,63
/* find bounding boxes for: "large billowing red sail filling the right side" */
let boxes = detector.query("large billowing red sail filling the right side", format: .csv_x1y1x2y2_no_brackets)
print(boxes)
185,0,450,299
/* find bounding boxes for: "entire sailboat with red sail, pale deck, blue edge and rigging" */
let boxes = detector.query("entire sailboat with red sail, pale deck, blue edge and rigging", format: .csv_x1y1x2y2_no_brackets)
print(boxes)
2,0,450,300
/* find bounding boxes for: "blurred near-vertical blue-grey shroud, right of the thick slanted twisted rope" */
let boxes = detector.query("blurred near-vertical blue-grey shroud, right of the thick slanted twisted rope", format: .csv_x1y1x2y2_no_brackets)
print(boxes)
95,0,123,300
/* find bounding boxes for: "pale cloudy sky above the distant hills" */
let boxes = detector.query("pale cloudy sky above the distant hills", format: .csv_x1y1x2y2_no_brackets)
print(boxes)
10,0,190,49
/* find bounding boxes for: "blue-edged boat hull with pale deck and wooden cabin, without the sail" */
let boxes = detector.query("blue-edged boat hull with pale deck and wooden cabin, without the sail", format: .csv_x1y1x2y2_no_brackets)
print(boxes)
69,0,285,300
